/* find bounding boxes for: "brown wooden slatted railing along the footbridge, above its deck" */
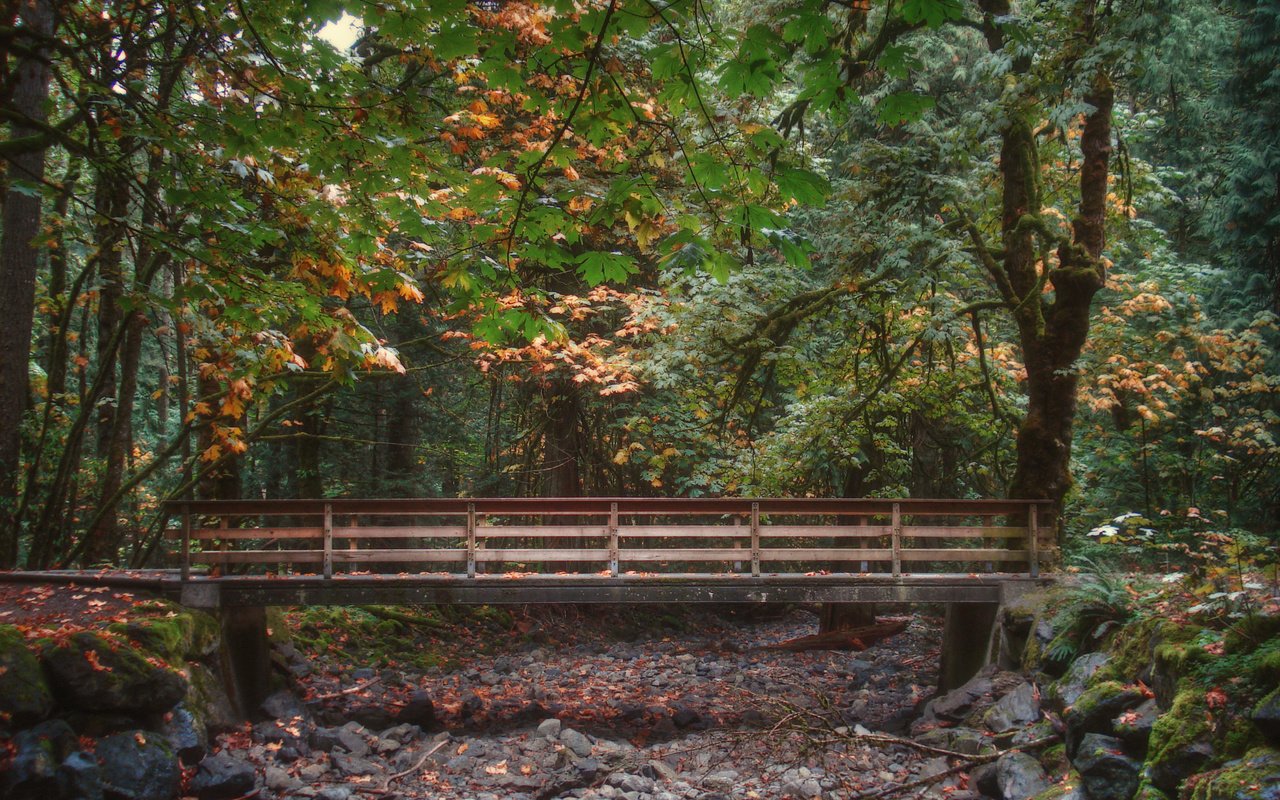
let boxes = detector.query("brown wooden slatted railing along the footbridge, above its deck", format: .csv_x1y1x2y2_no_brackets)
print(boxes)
168,498,1052,580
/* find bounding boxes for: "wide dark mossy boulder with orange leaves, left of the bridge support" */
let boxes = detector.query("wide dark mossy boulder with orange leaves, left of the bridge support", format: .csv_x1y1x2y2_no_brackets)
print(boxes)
44,632,187,714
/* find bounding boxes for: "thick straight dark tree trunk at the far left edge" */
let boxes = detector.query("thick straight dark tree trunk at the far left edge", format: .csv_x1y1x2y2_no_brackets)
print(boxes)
0,0,54,568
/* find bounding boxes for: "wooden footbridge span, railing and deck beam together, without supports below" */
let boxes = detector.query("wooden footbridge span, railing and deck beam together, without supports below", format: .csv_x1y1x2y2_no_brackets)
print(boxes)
168,498,1055,607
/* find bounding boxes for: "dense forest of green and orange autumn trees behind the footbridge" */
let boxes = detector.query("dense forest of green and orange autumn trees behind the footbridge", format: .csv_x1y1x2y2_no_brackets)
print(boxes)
0,0,1280,567
